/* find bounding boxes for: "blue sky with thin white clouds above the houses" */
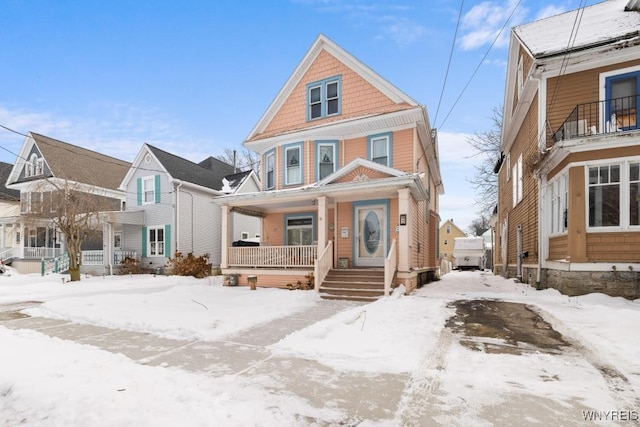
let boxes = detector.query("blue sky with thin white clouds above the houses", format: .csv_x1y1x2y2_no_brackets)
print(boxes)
0,0,596,229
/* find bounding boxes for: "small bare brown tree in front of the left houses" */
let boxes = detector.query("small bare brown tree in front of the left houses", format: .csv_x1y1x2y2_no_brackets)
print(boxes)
26,180,120,281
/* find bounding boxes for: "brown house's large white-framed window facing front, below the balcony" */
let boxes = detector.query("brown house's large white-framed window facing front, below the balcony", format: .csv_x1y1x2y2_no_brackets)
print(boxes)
588,165,620,227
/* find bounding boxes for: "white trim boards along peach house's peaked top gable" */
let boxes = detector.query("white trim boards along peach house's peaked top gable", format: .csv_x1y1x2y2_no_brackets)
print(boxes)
246,34,418,141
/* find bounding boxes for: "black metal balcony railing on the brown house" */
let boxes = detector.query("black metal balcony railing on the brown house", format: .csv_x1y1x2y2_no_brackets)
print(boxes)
553,95,640,142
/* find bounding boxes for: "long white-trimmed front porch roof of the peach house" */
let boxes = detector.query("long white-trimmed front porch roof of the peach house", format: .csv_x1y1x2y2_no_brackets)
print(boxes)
213,174,428,216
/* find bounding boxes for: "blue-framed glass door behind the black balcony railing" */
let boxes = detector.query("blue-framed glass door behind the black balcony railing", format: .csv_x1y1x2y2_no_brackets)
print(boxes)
605,67,640,132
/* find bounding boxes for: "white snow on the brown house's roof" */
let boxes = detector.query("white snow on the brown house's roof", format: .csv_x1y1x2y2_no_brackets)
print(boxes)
513,0,640,58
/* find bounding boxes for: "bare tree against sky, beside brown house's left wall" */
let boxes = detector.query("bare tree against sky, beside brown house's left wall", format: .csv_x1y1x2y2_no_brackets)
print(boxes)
467,107,502,218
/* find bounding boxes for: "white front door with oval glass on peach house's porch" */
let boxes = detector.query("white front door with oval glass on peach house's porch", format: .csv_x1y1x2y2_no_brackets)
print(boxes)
355,205,387,267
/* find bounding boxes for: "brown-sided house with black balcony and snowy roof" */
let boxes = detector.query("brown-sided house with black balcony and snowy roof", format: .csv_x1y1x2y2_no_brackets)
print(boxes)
495,0,640,298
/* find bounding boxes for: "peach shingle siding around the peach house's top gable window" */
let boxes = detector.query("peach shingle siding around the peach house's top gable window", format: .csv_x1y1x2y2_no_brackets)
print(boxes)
254,51,407,139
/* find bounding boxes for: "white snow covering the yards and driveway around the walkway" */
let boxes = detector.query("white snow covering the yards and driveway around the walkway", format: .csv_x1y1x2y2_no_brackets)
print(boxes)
0,272,640,426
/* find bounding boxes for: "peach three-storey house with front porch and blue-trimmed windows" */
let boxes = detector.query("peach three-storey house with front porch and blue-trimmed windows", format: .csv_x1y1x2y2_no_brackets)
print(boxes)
215,35,443,297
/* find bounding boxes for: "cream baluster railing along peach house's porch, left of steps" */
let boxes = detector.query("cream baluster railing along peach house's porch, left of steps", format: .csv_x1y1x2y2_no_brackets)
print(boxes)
227,245,318,267
